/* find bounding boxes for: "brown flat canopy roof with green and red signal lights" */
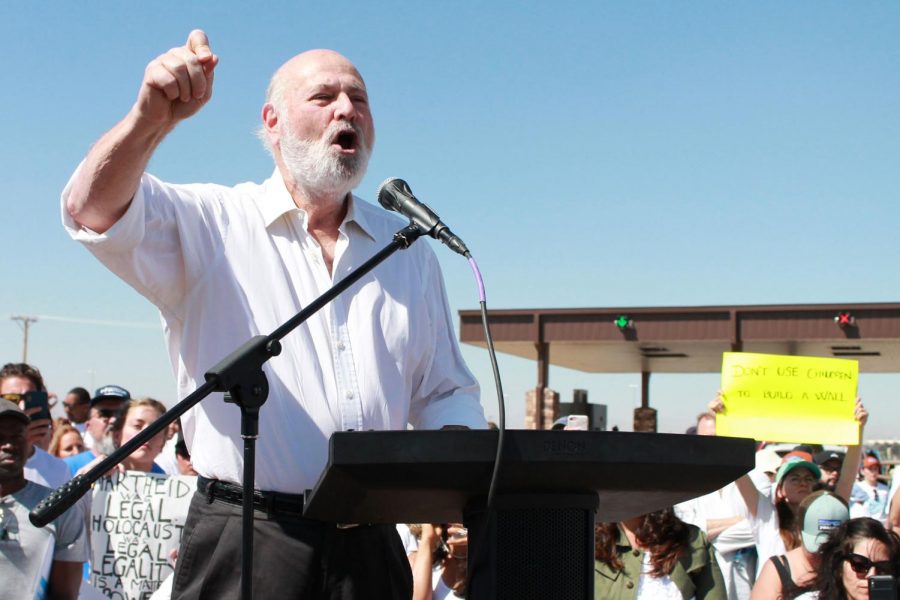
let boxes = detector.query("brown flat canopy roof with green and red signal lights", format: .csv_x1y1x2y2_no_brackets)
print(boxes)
459,303,900,373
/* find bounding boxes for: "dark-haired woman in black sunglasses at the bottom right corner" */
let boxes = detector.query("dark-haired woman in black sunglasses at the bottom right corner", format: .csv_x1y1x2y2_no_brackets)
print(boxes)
816,517,900,600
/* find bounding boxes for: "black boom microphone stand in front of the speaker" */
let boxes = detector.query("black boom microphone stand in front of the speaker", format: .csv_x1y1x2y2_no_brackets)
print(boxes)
29,222,428,600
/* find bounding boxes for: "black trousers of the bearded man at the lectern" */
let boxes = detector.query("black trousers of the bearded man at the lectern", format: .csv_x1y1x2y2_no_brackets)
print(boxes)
172,492,412,600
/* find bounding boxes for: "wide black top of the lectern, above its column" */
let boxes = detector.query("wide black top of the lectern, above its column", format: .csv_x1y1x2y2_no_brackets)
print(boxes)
304,430,755,523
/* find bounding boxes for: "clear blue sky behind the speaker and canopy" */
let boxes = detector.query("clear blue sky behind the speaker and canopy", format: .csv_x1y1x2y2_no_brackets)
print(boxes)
0,1,900,438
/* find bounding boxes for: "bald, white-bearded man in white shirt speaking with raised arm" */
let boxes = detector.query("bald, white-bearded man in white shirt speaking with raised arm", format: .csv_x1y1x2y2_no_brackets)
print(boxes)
62,30,486,599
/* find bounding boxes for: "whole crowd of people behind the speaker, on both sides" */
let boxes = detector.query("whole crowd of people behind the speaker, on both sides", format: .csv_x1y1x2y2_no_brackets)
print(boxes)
0,363,900,600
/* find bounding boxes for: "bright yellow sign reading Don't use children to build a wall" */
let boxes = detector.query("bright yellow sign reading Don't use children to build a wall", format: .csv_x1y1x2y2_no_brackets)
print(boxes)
716,352,859,445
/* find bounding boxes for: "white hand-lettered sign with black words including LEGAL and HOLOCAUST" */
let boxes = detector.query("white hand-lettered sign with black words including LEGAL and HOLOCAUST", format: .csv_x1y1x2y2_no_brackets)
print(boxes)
91,471,197,600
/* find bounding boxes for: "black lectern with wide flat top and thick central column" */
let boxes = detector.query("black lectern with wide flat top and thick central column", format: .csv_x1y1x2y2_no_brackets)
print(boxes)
304,430,755,600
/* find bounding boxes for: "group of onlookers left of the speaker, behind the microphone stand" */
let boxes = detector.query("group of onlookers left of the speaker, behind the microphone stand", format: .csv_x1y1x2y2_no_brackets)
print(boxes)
0,363,196,600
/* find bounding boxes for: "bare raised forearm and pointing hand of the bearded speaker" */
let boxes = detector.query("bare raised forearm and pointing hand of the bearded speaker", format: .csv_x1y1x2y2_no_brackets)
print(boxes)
66,29,219,233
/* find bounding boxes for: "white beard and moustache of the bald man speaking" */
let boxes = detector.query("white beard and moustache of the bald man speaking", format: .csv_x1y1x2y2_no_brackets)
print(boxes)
279,123,371,200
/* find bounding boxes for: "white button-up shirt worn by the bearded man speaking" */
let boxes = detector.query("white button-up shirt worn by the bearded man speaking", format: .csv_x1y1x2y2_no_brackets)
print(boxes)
62,169,486,493
